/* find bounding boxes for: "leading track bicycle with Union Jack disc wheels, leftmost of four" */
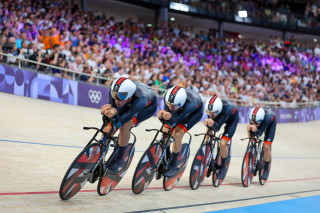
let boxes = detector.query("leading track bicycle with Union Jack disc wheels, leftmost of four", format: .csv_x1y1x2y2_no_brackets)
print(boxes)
59,116,136,200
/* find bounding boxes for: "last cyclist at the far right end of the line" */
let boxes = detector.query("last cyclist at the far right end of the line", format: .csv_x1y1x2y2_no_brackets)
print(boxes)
247,107,277,180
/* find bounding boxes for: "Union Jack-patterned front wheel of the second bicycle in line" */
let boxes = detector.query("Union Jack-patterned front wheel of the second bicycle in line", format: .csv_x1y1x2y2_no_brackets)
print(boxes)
131,143,162,194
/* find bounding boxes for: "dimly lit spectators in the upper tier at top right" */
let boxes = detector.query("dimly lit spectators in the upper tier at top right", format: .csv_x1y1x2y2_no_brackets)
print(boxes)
173,0,320,28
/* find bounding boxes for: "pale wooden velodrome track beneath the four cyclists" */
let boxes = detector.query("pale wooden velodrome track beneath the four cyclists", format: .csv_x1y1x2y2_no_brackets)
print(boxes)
0,93,320,212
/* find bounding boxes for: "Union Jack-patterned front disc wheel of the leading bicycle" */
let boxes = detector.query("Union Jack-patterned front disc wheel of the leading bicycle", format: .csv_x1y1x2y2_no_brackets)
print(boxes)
59,143,101,200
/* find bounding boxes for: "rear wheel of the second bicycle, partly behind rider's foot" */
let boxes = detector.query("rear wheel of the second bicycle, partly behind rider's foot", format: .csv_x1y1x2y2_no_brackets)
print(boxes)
163,143,190,191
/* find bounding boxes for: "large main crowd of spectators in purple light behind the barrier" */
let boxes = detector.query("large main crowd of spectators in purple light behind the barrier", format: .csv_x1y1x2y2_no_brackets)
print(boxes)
0,0,320,107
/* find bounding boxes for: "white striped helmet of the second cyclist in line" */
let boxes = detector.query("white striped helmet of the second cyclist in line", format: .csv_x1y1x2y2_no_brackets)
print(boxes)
164,86,187,108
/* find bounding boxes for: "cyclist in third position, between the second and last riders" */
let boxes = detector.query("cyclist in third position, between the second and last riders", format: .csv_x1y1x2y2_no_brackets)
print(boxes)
203,96,239,179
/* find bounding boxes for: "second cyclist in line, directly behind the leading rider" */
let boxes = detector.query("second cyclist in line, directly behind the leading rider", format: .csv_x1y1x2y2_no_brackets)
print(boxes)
158,86,203,177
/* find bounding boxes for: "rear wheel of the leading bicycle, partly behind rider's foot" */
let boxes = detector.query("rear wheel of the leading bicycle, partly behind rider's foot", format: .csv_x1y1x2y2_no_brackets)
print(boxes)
97,143,134,195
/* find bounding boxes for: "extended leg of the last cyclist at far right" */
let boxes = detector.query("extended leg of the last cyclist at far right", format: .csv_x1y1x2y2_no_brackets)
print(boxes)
261,117,277,180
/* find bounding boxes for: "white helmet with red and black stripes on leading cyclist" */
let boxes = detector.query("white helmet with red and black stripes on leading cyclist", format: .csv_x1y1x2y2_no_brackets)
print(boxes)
110,77,137,101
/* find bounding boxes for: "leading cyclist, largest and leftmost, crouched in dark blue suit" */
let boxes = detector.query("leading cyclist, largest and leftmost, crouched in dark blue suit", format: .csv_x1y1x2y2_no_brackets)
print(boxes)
101,77,158,171
